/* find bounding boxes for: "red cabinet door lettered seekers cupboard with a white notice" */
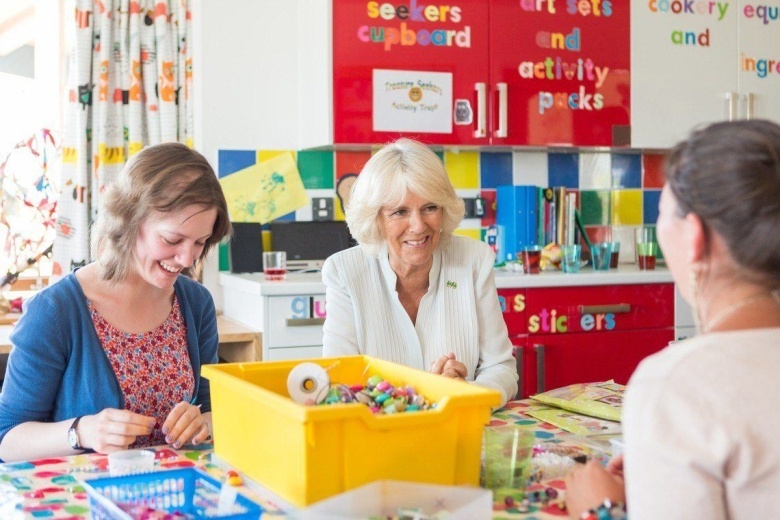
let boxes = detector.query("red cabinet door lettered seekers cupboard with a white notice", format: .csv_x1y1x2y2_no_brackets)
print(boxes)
333,0,489,144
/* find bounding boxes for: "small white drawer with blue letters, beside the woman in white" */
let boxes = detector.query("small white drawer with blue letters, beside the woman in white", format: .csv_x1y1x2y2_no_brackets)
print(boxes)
263,294,325,349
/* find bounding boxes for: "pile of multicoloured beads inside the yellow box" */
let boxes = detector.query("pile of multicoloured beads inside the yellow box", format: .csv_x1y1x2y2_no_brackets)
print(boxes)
320,375,436,414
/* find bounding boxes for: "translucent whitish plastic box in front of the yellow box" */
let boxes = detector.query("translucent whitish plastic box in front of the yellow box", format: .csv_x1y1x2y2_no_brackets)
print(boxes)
291,480,493,520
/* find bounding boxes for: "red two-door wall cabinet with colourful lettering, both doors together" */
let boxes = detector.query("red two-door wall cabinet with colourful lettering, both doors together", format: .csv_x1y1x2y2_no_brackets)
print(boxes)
332,0,630,146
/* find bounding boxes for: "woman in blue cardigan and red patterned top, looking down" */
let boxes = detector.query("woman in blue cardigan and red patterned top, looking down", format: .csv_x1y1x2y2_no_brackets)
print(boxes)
0,143,231,461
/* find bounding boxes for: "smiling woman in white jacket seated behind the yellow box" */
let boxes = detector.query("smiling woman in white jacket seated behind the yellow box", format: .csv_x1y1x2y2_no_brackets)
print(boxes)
322,139,518,408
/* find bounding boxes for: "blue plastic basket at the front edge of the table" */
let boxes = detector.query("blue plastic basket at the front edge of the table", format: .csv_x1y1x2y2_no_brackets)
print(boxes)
83,468,263,520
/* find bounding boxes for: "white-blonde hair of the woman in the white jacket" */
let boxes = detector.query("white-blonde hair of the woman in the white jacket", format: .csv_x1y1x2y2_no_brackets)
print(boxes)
345,138,465,255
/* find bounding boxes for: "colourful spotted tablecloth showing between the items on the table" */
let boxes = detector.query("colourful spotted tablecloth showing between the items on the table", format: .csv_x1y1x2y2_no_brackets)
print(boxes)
0,400,608,520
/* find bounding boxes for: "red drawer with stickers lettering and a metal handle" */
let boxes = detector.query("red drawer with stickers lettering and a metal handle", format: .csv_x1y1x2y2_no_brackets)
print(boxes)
522,283,674,334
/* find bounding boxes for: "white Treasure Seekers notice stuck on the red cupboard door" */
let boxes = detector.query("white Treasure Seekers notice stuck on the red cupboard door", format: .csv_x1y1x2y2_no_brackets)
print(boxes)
373,69,452,134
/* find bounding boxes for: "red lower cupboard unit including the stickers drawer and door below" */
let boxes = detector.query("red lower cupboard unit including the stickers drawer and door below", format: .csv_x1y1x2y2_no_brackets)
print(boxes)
499,283,674,397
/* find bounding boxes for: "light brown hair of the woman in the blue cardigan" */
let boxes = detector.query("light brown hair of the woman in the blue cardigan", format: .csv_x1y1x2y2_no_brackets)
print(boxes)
92,143,232,282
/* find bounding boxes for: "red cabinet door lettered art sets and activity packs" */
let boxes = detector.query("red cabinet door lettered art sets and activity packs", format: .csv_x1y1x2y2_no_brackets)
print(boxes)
490,0,630,146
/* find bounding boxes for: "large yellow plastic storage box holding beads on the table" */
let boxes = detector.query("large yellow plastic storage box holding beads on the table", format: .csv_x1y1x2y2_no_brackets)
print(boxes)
202,356,501,506
